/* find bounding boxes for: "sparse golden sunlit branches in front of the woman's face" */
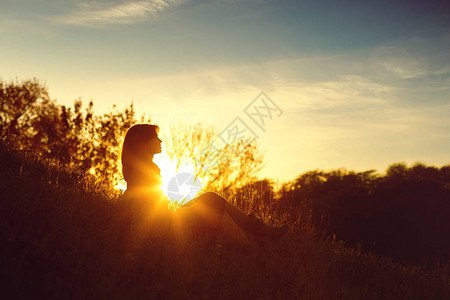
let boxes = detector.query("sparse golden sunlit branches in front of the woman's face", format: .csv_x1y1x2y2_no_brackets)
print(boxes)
166,123,262,196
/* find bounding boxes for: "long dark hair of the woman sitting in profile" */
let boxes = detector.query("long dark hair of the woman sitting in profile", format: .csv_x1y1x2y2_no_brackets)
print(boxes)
122,124,159,182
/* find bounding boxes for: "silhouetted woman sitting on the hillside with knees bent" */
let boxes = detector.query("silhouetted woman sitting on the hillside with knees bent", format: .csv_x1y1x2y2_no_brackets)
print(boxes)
122,124,287,244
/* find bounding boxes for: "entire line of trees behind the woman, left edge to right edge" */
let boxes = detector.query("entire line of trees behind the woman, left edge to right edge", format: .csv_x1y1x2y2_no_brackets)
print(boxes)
0,79,450,264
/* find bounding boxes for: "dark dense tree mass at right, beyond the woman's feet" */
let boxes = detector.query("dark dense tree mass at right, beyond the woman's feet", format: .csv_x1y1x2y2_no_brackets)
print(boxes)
280,163,450,265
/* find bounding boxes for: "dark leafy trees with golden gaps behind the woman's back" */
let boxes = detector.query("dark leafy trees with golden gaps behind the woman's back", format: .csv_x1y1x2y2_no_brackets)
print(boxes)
0,79,142,185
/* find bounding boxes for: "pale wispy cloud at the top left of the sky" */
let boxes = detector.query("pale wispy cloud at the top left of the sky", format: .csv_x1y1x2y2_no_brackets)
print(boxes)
49,0,180,27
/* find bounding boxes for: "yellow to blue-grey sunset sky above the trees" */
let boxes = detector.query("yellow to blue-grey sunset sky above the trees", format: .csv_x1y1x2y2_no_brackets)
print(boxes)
0,0,450,182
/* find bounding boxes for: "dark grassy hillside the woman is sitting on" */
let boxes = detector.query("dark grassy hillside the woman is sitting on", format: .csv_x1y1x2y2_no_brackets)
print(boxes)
0,144,450,299
